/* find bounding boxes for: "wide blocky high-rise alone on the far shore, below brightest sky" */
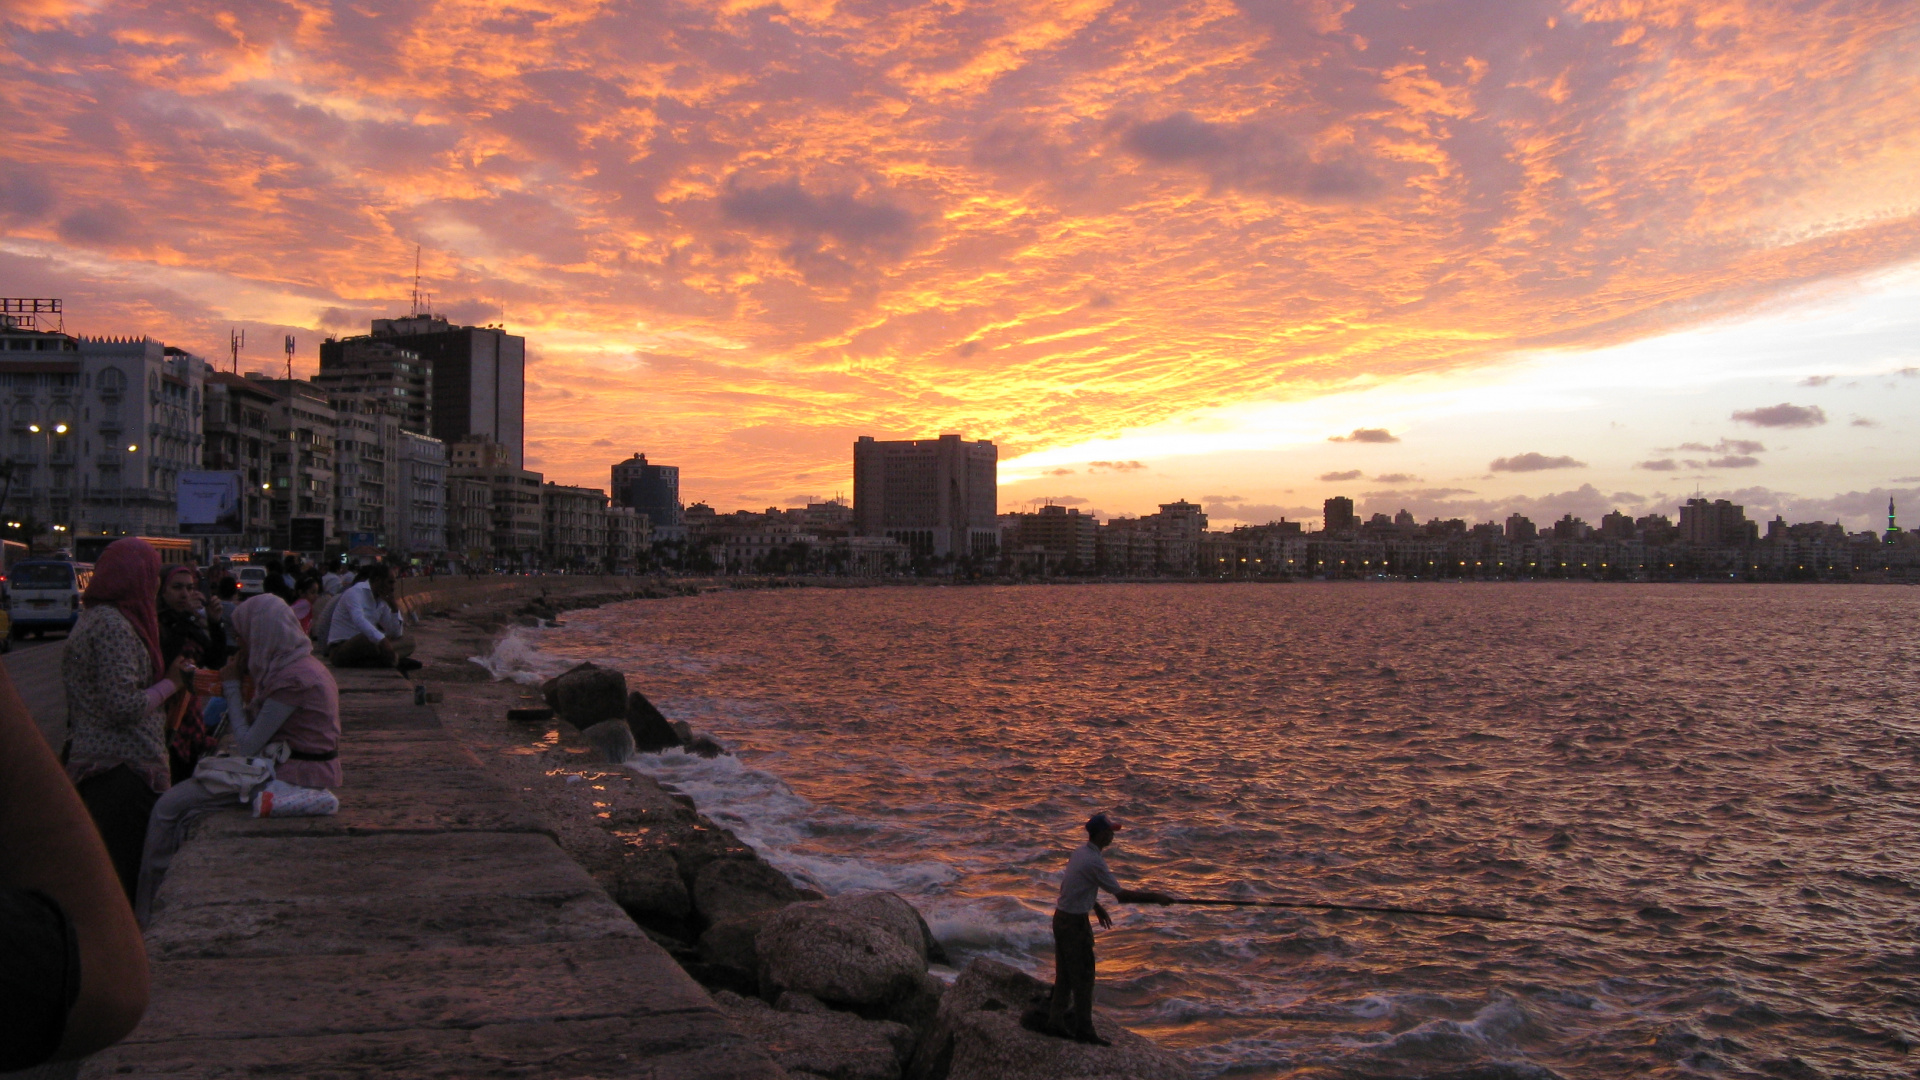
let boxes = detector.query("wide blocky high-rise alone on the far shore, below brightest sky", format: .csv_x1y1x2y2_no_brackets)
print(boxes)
852,434,1000,559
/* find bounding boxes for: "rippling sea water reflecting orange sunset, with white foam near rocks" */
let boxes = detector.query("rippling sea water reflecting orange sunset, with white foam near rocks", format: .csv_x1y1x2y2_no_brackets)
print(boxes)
488,584,1920,1078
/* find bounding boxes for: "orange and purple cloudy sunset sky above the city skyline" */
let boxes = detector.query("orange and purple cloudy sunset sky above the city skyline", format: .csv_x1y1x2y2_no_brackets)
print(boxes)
0,0,1920,527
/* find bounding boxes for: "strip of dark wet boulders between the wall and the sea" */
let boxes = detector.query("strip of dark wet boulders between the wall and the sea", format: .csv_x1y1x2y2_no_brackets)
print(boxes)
518,663,1190,1080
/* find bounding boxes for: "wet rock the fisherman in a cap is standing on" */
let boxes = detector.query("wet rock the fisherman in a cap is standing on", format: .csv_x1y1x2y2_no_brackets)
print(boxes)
906,961,1194,1080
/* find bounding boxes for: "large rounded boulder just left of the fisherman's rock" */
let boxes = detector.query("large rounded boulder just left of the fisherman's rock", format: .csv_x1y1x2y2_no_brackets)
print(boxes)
755,896,931,1015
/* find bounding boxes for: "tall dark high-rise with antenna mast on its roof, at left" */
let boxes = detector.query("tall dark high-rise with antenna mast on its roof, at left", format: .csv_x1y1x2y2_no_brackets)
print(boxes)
360,315,526,467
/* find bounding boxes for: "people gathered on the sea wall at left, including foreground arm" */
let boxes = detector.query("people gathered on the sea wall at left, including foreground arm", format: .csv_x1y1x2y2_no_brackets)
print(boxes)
0,536,419,1072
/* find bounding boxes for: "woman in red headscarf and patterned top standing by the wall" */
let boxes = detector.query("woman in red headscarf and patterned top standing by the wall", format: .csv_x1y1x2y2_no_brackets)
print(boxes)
60,536,192,897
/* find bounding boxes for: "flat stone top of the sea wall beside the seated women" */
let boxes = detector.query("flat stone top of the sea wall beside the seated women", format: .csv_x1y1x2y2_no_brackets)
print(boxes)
74,665,785,1080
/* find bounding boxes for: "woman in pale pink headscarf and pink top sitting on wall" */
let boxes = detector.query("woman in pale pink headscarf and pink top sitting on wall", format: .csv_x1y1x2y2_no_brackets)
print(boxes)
134,594,340,926
